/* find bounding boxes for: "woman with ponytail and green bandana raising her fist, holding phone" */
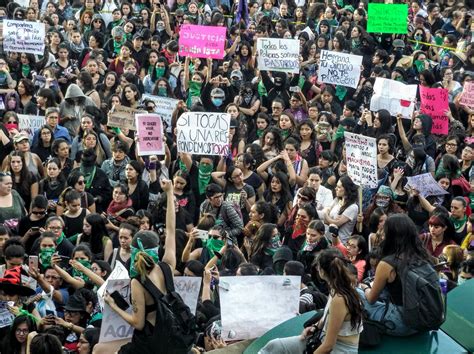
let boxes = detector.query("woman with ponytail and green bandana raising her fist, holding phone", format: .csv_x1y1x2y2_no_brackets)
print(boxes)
103,180,176,353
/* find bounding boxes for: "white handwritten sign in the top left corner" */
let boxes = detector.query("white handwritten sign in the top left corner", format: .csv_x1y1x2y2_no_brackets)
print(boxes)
3,20,46,55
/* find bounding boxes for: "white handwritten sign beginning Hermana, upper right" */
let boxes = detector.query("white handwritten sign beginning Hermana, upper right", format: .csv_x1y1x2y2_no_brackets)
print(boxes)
318,50,362,88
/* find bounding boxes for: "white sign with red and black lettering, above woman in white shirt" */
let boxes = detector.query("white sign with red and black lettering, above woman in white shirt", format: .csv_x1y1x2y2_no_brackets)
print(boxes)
344,132,378,188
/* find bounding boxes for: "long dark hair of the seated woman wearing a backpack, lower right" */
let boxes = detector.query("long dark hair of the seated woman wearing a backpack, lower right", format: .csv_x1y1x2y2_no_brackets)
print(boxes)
381,214,429,263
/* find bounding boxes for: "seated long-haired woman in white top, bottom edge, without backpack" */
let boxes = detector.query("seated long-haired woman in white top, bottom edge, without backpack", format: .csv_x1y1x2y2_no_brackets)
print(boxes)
259,249,364,354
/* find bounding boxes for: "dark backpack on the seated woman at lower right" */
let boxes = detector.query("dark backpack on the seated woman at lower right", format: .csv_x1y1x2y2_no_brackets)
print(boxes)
397,261,445,332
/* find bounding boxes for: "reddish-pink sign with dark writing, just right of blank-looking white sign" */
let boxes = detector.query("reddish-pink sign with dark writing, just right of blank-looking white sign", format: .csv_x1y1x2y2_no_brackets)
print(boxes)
420,86,449,135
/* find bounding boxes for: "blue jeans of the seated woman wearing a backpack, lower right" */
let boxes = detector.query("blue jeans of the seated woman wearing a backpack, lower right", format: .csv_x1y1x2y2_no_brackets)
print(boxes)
356,288,417,337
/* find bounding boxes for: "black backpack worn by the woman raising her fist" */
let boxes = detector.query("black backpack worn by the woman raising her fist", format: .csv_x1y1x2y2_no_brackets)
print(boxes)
140,262,198,354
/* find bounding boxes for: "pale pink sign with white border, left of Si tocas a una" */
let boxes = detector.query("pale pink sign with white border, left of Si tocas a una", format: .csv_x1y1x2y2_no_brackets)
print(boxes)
135,113,165,156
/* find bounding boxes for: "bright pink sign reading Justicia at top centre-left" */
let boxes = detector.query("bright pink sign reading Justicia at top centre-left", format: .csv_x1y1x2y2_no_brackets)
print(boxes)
179,25,226,59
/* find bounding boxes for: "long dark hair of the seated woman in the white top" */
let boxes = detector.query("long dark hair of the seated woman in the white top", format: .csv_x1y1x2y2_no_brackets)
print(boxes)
316,250,364,330
